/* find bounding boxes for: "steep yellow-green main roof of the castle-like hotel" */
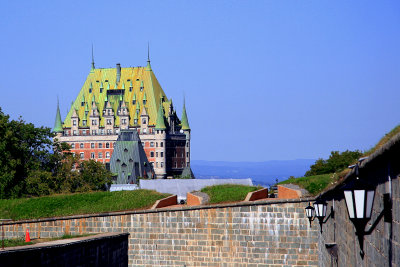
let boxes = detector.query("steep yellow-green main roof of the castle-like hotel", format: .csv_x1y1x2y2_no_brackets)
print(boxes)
64,64,170,127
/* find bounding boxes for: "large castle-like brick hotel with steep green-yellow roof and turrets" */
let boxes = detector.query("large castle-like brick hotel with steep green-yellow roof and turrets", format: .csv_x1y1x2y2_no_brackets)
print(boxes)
53,55,190,178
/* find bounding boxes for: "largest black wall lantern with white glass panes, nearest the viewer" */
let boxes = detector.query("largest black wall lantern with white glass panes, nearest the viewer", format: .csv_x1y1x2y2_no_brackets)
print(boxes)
344,165,375,257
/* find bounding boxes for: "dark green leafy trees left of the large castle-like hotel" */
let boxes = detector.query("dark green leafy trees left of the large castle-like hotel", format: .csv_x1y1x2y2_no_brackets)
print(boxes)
0,109,111,198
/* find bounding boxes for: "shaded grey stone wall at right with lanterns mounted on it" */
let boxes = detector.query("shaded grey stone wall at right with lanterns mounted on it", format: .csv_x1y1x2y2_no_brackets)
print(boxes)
313,140,400,267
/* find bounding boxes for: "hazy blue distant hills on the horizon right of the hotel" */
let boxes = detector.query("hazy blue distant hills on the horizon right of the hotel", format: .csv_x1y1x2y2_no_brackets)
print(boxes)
191,159,315,186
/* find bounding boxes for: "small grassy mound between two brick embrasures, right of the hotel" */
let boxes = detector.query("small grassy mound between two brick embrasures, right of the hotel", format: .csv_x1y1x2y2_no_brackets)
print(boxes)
201,184,262,204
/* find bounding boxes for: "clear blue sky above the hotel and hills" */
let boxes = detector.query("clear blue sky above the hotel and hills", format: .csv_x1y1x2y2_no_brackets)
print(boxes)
0,0,400,161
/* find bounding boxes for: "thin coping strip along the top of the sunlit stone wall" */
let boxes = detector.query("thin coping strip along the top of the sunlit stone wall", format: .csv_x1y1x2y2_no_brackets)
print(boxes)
0,197,316,225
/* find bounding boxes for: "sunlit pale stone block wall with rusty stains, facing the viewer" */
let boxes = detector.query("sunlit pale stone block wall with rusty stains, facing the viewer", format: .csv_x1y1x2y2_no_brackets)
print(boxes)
4,199,318,266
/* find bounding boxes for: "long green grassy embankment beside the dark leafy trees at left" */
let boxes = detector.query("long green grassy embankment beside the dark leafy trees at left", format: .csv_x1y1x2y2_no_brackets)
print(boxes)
0,190,170,220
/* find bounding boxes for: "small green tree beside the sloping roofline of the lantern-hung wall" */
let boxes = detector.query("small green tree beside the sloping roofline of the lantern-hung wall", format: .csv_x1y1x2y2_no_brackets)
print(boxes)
305,150,362,176
